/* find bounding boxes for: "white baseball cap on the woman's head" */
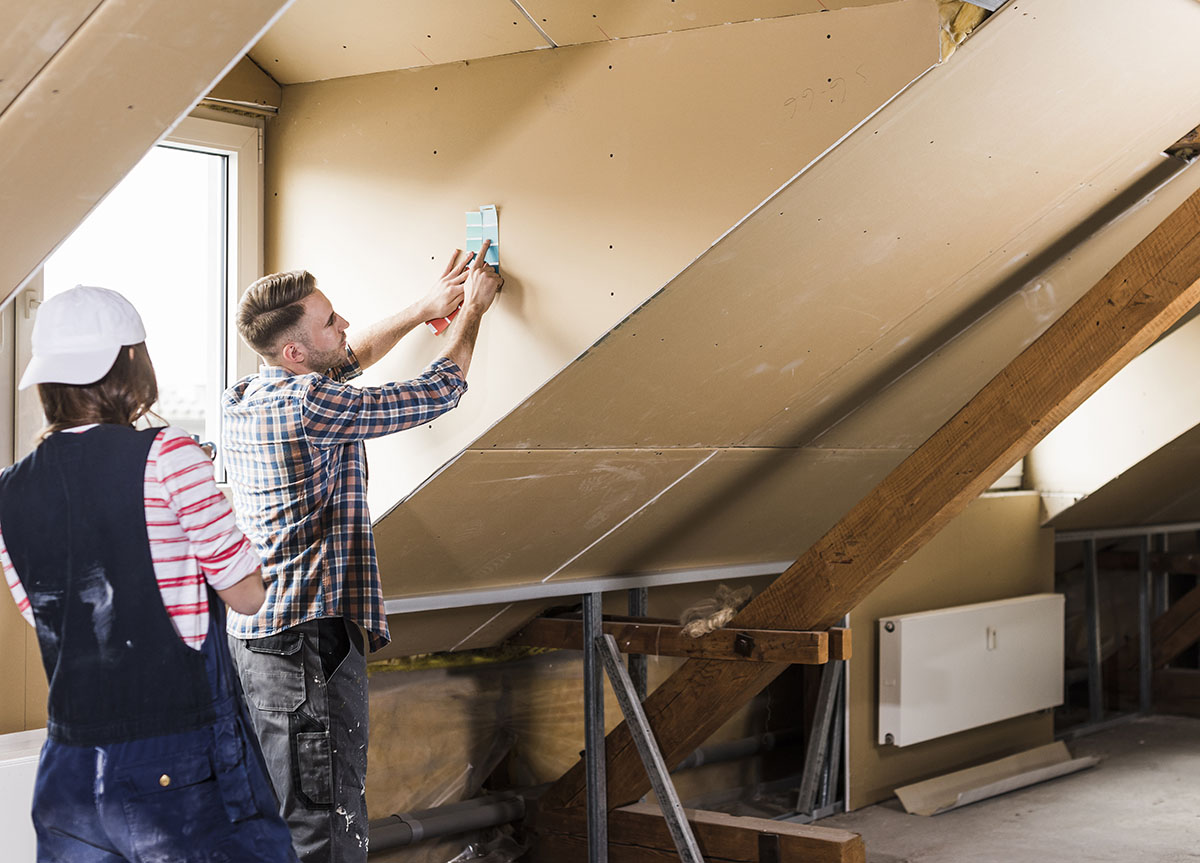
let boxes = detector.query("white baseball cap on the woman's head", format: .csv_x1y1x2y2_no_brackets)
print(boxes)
18,284,146,389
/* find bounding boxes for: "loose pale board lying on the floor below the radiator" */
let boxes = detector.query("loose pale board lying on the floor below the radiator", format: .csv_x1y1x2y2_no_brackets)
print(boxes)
896,741,1099,815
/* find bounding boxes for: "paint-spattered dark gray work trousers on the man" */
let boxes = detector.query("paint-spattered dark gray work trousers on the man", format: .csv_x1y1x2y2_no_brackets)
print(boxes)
229,617,368,863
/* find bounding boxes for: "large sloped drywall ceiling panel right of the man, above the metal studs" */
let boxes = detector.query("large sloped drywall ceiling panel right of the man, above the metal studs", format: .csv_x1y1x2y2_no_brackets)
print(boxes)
360,0,1200,628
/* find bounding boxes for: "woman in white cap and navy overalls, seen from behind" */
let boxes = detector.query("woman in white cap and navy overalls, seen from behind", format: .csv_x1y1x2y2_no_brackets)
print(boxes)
0,287,296,863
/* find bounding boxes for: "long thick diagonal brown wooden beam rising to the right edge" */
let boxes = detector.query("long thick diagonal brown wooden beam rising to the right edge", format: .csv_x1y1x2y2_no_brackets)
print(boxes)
542,180,1200,807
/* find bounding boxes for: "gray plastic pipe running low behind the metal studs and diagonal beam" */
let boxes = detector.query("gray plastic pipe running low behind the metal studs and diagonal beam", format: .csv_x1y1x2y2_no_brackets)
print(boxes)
368,730,804,852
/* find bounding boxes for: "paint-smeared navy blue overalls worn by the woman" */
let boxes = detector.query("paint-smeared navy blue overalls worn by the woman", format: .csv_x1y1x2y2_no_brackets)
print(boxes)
0,425,296,863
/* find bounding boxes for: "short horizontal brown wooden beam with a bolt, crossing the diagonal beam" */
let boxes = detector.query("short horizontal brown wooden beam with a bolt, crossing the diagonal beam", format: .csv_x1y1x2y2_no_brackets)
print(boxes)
510,617,829,665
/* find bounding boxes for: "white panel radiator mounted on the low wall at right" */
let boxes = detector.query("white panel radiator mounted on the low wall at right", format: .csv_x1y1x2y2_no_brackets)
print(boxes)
878,593,1064,747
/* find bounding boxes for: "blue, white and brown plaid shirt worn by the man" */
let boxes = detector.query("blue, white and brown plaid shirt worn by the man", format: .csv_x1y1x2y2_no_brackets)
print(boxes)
222,348,467,649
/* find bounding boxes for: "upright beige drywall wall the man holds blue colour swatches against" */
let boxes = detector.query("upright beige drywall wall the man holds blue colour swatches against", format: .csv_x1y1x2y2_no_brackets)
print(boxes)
266,0,937,514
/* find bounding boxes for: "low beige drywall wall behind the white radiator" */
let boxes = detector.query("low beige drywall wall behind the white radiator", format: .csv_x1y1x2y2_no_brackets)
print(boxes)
846,492,1054,809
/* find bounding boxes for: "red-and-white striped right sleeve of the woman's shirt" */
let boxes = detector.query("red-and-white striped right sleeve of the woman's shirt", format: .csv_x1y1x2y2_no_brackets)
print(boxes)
154,428,260,591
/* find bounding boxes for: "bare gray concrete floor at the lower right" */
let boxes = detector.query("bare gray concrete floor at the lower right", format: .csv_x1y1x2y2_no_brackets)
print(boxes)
818,717,1200,863
